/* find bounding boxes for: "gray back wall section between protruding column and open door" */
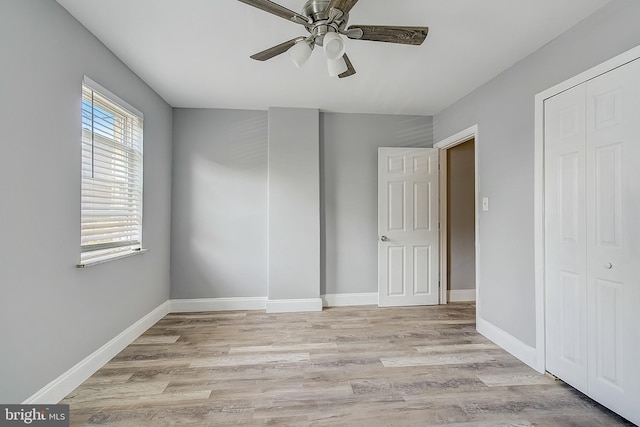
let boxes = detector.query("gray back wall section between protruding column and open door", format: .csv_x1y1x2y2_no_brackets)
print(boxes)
320,113,433,294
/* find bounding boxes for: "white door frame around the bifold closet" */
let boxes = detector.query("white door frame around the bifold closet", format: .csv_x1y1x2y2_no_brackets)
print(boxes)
534,46,640,373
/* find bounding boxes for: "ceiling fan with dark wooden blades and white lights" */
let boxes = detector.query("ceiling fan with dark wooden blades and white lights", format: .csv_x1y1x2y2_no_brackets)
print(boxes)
239,0,429,78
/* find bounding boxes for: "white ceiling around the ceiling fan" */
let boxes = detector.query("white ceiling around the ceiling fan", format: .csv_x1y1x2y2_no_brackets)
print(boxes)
57,0,609,115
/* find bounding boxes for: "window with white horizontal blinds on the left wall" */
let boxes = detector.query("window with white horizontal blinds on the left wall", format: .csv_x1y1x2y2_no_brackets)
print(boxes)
79,77,143,267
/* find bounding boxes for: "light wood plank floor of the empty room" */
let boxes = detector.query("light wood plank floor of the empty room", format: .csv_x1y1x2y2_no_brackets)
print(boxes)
61,304,632,427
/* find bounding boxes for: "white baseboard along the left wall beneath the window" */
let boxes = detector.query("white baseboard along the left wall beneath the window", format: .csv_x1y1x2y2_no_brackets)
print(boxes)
22,301,170,405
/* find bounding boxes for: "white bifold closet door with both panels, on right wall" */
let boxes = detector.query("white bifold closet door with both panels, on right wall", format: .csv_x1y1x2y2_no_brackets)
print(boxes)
545,60,640,423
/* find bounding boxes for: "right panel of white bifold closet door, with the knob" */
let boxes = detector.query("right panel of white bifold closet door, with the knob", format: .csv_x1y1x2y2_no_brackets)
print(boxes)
586,56,640,423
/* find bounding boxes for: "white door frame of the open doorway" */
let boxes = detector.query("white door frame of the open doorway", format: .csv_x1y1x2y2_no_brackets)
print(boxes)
433,124,480,308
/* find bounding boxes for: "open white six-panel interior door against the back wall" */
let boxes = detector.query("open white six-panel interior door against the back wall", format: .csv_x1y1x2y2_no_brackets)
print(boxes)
378,148,439,307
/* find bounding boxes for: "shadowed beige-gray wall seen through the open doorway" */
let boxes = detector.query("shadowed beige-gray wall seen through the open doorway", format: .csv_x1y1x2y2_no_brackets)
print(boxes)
447,140,476,291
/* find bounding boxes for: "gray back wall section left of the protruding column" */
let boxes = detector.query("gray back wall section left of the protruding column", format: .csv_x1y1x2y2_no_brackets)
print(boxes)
171,109,268,298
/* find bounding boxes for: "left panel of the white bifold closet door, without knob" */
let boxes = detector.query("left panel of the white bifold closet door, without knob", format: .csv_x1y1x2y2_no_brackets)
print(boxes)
545,82,588,393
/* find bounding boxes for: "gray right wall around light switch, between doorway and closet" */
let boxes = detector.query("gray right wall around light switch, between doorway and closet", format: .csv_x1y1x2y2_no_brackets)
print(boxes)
436,0,640,347
